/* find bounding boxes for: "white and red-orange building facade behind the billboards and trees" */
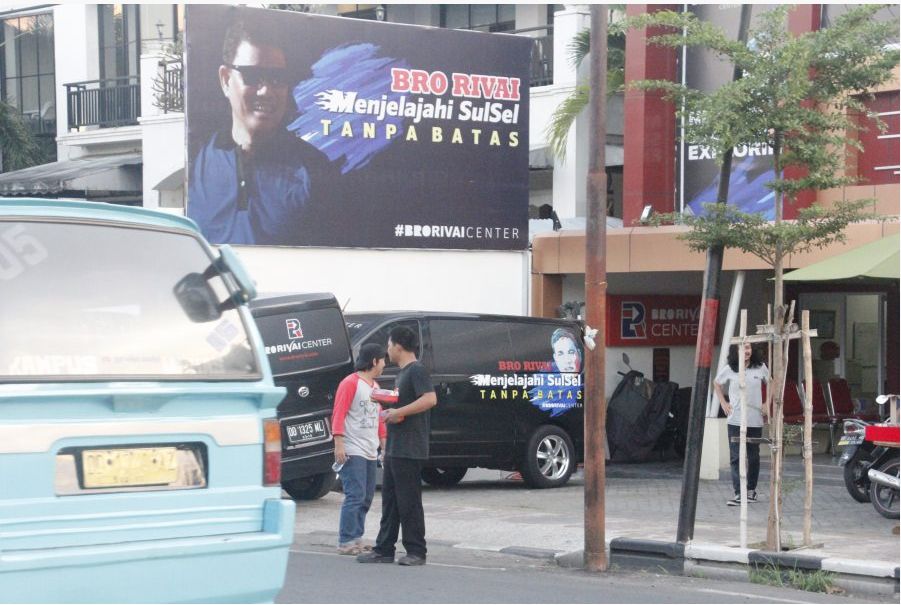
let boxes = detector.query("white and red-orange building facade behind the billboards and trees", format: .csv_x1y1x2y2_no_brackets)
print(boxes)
0,3,899,430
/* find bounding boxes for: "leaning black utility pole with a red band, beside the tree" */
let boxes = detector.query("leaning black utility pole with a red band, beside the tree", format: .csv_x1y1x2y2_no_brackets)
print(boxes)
676,4,751,544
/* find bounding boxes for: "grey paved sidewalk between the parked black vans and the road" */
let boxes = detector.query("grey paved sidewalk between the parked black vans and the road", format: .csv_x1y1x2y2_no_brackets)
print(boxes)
296,456,899,590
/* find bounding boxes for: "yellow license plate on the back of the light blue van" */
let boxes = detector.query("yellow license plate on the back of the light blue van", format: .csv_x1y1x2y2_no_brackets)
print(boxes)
81,447,178,488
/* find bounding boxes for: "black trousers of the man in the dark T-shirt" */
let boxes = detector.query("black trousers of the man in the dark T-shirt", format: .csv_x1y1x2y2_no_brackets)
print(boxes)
373,456,426,558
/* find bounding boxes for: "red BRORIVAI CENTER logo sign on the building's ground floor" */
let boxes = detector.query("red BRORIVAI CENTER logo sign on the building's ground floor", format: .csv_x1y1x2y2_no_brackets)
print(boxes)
607,295,701,347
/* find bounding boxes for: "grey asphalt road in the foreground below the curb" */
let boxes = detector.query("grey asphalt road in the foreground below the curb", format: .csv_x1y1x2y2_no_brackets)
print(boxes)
277,539,867,604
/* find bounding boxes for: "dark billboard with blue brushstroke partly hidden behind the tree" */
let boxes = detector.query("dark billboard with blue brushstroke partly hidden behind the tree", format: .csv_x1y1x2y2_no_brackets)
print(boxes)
681,4,776,220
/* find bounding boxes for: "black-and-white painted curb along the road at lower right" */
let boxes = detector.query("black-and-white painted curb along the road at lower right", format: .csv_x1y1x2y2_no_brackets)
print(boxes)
555,538,899,596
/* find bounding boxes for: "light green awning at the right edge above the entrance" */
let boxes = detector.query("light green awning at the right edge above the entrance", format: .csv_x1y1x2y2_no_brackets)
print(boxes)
783,233,901,281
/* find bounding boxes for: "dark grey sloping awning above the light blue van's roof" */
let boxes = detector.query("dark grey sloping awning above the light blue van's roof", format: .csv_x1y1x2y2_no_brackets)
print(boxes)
0,152,142,195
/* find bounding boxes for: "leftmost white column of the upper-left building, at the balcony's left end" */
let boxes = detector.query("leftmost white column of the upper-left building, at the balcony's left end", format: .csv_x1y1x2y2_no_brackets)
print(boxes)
53,4,100,160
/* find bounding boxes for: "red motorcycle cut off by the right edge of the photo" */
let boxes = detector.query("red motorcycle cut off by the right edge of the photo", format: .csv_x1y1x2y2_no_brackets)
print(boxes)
865,395,901,519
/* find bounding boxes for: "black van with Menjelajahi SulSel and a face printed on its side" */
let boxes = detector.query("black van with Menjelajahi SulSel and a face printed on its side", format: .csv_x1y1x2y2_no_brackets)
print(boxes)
345,312,584,488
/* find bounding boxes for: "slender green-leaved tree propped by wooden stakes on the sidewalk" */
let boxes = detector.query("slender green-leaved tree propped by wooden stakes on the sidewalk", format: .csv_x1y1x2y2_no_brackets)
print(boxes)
627,5,899,551
